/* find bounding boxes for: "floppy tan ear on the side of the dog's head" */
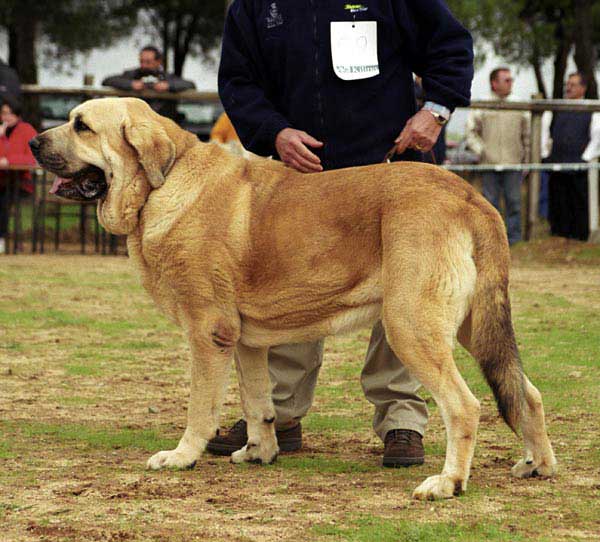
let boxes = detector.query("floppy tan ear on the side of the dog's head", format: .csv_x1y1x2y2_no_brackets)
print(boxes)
123,119,177,188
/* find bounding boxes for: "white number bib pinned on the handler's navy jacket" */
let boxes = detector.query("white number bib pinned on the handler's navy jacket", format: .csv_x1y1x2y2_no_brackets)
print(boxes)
331,21,379,81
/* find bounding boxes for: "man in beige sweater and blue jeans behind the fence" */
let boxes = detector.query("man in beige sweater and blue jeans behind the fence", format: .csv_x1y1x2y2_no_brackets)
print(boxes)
467,68,530,245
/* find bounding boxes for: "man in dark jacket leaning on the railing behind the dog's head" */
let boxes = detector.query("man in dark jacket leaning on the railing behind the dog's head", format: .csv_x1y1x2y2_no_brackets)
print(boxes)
102,45,196,121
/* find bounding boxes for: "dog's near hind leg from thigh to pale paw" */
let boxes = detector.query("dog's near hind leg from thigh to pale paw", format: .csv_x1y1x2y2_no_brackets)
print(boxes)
382,238,480,499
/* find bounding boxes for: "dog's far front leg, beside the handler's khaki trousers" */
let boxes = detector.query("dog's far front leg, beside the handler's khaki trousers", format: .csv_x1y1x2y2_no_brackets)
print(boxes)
231,343,279,464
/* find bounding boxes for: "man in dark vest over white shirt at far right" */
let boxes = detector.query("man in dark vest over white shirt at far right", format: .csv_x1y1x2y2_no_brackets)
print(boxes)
542,73,600,241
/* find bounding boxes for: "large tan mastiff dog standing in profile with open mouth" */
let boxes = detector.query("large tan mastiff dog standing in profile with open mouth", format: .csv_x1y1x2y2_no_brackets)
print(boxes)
31,98,556,499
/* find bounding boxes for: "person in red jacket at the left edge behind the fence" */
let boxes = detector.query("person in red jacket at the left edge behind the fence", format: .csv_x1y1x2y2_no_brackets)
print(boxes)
0,97,37,254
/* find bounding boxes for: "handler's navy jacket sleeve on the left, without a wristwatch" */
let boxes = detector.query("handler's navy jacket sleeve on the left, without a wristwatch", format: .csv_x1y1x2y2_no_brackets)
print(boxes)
219,0,290,156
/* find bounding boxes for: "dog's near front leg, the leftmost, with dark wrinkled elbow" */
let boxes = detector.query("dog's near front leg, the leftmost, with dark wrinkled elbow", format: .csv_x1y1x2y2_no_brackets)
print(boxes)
147,320,237,469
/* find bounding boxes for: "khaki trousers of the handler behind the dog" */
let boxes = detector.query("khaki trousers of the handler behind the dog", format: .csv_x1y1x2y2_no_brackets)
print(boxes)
269,322,427,440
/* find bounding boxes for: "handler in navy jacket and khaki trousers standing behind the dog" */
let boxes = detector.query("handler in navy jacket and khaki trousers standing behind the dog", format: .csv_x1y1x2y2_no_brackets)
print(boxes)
207,0,473,467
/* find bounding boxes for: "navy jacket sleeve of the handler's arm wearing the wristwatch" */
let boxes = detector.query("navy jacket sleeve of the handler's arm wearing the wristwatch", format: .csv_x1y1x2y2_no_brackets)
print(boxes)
395,0,473,111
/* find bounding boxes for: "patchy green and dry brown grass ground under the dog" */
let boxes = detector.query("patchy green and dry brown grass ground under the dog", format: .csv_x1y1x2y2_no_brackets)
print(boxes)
0,241,600,542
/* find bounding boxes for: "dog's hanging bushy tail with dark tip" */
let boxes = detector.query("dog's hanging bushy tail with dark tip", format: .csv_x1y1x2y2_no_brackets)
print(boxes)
470,220,525,433
